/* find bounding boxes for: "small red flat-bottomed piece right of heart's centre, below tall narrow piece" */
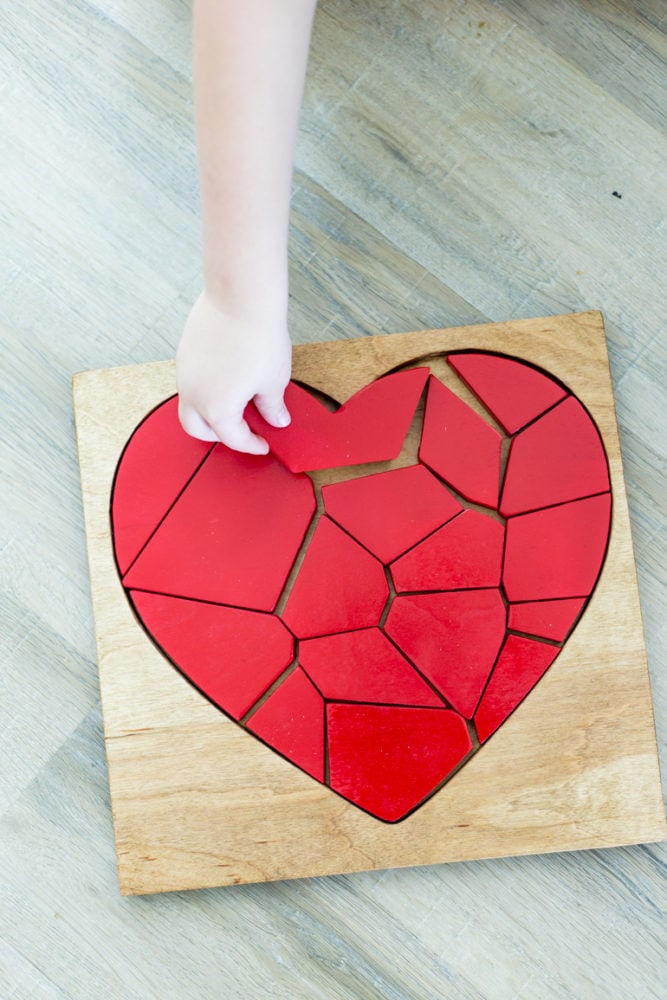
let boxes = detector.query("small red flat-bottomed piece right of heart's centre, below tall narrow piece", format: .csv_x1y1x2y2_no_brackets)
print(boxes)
391,510,505,593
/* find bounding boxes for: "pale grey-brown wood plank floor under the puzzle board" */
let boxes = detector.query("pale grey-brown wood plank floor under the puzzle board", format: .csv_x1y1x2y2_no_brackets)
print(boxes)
0,0,667,1000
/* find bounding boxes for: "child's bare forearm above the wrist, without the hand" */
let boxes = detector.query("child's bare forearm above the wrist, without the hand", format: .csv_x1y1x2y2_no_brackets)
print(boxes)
193,0,316,309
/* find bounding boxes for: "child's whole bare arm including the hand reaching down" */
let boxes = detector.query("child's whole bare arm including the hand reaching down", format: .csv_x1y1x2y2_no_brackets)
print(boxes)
176,0,316,453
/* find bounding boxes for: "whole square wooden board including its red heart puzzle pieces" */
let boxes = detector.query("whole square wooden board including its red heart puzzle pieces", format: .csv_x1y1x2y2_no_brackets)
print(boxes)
74,312,665,894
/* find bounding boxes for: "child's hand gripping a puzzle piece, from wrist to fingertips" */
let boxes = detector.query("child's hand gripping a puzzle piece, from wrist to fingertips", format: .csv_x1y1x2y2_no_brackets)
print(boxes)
176,292,292,455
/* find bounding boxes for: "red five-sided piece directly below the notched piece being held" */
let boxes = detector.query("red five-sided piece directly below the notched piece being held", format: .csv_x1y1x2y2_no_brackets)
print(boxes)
322,465,461,563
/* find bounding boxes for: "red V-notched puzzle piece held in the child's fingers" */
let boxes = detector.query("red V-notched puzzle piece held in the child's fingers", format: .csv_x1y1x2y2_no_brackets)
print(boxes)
245,368,429,472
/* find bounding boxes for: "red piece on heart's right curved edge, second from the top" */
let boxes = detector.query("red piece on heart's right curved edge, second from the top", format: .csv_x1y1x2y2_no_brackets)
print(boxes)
500,396,609,517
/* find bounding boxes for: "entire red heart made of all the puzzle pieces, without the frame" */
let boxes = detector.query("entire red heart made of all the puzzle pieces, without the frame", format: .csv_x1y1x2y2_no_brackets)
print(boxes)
111,351,611,822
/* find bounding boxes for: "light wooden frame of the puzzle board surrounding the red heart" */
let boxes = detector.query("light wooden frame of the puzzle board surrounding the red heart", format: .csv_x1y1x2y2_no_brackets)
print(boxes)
74,313,666,894
